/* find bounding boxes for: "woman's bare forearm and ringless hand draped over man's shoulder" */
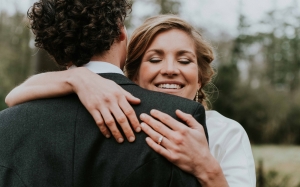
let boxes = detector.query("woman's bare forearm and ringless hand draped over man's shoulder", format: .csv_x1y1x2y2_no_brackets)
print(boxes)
5,68,140,143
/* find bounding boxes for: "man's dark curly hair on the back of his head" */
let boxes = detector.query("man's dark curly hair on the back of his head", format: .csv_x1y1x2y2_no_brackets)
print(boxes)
27,0,131,66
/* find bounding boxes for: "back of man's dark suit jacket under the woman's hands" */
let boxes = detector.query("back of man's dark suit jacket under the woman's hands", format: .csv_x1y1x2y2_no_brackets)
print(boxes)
0,74,206,187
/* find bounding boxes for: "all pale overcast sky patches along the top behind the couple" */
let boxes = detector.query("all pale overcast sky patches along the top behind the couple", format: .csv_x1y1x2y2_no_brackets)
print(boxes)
0,0,300,36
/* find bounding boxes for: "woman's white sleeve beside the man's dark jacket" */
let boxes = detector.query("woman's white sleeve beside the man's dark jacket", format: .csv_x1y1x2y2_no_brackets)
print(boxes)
206,111,256,187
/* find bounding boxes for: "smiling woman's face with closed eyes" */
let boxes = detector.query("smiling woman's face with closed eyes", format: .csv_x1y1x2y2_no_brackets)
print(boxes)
135,29,200,99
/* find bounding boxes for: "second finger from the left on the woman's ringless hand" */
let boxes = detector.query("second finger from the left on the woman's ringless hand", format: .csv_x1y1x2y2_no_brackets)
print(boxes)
100,108,124,143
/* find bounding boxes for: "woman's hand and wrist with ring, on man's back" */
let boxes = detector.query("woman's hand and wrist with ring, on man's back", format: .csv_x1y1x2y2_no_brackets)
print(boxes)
140,110,228,187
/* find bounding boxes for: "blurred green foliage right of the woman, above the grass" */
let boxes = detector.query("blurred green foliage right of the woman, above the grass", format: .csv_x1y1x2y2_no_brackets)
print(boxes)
213,1,300,144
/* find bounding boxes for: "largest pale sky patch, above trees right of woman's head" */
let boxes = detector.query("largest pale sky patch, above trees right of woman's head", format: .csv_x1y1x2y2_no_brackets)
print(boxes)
179,0,298,28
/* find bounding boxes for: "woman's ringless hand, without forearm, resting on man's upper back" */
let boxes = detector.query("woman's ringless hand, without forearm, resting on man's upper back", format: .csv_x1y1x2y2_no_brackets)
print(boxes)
67,68,141,143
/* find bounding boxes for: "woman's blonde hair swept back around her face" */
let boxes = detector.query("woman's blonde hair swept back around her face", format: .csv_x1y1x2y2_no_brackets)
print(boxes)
125,15,214,108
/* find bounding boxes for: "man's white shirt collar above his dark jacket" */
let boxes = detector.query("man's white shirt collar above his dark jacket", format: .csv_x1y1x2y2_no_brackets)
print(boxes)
68,61,124,75
